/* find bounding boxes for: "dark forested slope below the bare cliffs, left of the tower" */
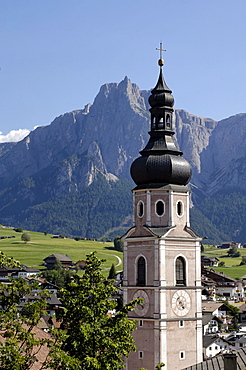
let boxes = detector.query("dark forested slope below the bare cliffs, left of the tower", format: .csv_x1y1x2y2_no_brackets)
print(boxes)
12,175,132,238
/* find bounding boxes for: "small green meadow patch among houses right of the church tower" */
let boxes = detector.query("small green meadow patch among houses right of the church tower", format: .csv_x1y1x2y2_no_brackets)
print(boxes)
203,246,246,279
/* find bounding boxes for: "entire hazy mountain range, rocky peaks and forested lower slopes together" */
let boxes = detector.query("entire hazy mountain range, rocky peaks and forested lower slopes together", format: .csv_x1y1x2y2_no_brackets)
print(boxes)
0,77,246,243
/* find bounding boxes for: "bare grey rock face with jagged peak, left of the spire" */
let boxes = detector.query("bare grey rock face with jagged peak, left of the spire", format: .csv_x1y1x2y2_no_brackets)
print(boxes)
0,77,149,196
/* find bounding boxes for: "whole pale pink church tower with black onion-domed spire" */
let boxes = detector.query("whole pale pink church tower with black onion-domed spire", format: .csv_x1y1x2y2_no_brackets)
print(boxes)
123,49,202,370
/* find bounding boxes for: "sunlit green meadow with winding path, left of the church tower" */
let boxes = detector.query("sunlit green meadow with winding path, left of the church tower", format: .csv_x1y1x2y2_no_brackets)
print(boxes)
0,228,123,271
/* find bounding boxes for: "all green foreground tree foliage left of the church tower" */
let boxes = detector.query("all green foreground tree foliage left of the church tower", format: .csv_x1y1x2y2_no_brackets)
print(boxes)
0,252,142,370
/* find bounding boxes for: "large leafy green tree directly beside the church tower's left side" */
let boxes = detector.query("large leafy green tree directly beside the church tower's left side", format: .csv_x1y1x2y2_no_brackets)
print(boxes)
56,253,140,370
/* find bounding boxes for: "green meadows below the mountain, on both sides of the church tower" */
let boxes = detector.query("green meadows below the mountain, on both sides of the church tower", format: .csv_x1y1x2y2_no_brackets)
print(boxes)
0,228,246,278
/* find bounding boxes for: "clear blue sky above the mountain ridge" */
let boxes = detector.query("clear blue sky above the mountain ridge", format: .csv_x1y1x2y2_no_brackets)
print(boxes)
0,0,246,141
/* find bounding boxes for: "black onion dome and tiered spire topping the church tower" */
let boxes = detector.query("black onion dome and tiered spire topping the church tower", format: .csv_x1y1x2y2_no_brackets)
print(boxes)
131,59,191,186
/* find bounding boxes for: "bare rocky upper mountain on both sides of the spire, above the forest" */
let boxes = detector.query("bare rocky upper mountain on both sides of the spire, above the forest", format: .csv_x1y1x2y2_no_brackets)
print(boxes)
0,77,246,211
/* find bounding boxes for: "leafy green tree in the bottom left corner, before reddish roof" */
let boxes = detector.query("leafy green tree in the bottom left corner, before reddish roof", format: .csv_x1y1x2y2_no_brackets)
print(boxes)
0,278,52,370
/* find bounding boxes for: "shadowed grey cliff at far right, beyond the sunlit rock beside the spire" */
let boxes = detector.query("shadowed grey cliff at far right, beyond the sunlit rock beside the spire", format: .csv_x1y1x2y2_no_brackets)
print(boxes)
197,114,246,195
